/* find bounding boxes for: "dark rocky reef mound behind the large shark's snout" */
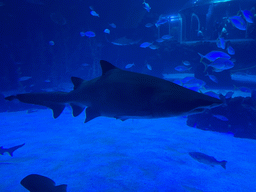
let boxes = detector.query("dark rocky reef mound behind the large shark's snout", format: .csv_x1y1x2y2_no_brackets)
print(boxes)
187,92,256,139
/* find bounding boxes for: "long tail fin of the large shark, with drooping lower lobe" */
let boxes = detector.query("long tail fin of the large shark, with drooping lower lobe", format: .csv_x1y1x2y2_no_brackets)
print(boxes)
5,92,68,118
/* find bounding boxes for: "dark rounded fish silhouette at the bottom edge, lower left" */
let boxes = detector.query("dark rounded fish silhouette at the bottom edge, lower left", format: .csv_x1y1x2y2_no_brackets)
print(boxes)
20,174,67,192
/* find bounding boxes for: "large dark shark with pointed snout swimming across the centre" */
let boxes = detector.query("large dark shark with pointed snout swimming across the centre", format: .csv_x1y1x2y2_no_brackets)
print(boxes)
5,60,222,122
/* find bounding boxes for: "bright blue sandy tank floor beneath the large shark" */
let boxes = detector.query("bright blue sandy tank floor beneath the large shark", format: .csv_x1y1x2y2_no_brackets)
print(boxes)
0,104,256,192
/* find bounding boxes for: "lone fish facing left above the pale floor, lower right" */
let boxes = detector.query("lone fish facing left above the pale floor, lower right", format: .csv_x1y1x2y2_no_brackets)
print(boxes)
189,152,227,169
